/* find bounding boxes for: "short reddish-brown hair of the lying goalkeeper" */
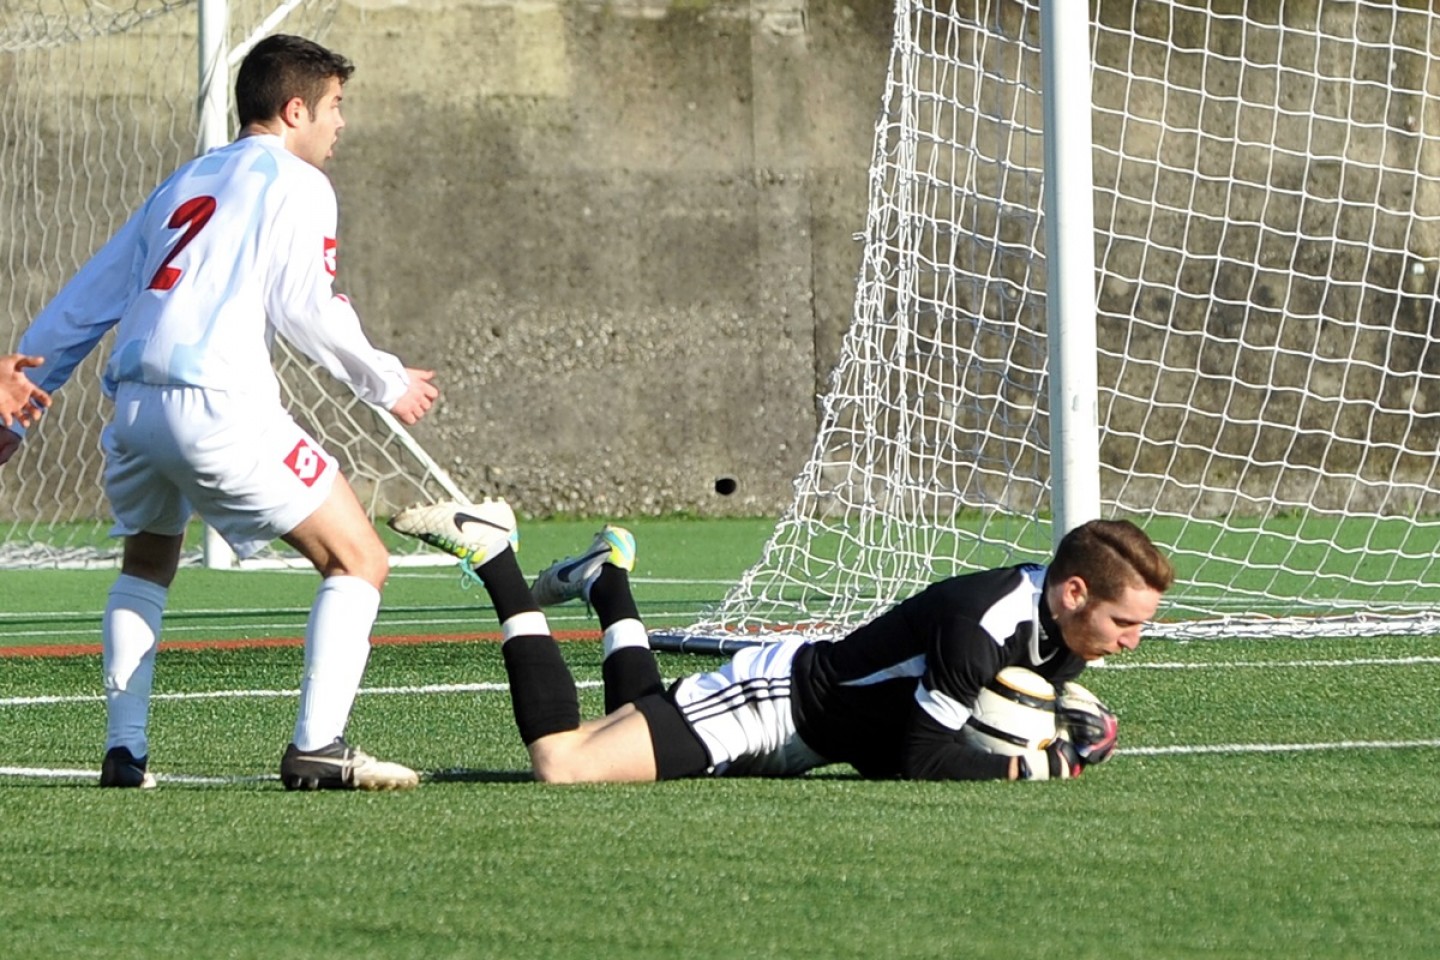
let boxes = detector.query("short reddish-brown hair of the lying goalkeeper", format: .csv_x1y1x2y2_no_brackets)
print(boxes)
1048,520,1175,600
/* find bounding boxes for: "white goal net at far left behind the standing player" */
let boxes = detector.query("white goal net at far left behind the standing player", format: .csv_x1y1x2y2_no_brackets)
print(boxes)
0,0,459,567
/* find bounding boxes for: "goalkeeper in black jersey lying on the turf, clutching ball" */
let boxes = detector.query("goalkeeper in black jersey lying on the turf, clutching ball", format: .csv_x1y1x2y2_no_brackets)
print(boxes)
390,499,1174,783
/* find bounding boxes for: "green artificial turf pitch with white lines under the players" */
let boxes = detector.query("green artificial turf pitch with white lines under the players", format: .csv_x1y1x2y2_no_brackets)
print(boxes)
0,521,1440,960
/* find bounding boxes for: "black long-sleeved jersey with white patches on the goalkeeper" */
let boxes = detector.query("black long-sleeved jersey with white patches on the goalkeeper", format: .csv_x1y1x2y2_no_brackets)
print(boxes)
791,564,1084,779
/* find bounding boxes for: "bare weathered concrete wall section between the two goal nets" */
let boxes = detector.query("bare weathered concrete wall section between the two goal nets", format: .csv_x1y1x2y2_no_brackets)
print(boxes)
325,0,891,514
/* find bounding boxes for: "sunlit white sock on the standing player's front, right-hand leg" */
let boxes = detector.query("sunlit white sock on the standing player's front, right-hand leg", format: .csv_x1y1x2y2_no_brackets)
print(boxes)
294,577,380,750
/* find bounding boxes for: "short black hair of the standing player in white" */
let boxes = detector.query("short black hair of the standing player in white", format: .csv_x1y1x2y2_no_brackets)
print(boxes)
235,33,356,127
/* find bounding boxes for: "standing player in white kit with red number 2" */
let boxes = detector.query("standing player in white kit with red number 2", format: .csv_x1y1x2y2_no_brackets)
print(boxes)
0,36,439,790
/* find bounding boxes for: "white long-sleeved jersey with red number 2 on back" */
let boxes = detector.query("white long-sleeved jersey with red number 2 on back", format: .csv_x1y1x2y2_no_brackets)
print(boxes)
19,135,409,409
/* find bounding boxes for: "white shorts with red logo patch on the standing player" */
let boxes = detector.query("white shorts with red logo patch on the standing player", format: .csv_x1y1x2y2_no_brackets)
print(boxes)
101,383,340,557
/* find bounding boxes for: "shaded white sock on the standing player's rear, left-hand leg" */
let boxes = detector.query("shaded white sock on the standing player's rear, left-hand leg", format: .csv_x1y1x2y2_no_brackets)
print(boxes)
101,573,170,757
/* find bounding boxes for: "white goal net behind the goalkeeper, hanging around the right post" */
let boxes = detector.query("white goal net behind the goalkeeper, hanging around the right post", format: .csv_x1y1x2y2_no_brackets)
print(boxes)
657,0,1440,649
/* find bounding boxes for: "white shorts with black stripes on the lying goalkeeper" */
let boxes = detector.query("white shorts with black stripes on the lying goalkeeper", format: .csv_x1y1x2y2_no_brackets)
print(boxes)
671,639,827,777
